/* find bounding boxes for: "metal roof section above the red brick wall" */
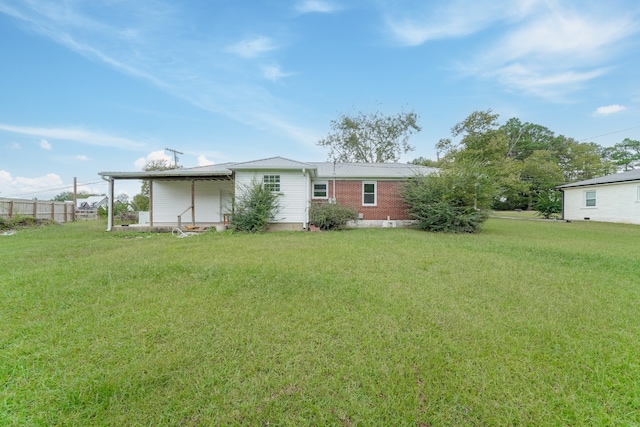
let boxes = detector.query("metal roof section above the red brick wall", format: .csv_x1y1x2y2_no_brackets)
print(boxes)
310,162,437,179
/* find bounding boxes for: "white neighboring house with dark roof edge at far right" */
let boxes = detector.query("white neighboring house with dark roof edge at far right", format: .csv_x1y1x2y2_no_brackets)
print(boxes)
558,169,640,224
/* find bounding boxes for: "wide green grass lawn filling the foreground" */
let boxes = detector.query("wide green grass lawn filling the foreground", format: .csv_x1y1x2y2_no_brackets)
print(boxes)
0,218,640,426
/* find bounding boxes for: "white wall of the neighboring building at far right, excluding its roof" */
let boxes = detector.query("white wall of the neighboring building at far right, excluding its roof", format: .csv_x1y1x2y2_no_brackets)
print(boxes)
564,182,640,224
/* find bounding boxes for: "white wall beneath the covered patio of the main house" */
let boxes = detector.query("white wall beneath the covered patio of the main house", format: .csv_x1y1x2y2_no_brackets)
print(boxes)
153,181,232,224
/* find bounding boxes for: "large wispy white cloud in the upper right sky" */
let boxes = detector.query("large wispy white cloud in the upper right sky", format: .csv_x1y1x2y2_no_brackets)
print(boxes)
386,0,639,99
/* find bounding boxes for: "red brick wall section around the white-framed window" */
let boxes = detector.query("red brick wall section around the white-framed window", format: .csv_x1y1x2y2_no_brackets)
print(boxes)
314,180,410,220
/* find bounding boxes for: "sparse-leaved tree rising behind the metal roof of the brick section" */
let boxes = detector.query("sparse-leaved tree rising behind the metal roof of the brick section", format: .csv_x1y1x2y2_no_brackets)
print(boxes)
317,112,422,163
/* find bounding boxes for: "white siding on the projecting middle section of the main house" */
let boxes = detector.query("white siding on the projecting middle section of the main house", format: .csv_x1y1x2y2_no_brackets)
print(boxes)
236,170,309,223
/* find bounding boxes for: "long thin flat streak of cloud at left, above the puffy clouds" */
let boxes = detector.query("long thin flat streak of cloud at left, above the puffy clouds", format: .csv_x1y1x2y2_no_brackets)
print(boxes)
0,123,146,150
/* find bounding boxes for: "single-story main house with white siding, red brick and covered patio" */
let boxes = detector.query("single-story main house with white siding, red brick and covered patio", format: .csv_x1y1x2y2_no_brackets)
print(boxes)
100,157,435,230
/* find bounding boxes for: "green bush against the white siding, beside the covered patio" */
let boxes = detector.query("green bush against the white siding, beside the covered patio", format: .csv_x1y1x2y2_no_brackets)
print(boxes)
230,181,279,233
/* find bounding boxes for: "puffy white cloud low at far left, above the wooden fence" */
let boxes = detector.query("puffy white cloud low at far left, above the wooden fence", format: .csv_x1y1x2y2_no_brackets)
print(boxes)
0,170,64,199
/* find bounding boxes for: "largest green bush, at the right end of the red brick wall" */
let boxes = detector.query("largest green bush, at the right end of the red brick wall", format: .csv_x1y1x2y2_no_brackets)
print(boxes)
402,170,491,233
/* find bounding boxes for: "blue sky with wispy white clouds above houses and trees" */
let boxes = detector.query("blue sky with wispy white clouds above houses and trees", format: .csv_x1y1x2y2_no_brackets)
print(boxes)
0,0,640,200
